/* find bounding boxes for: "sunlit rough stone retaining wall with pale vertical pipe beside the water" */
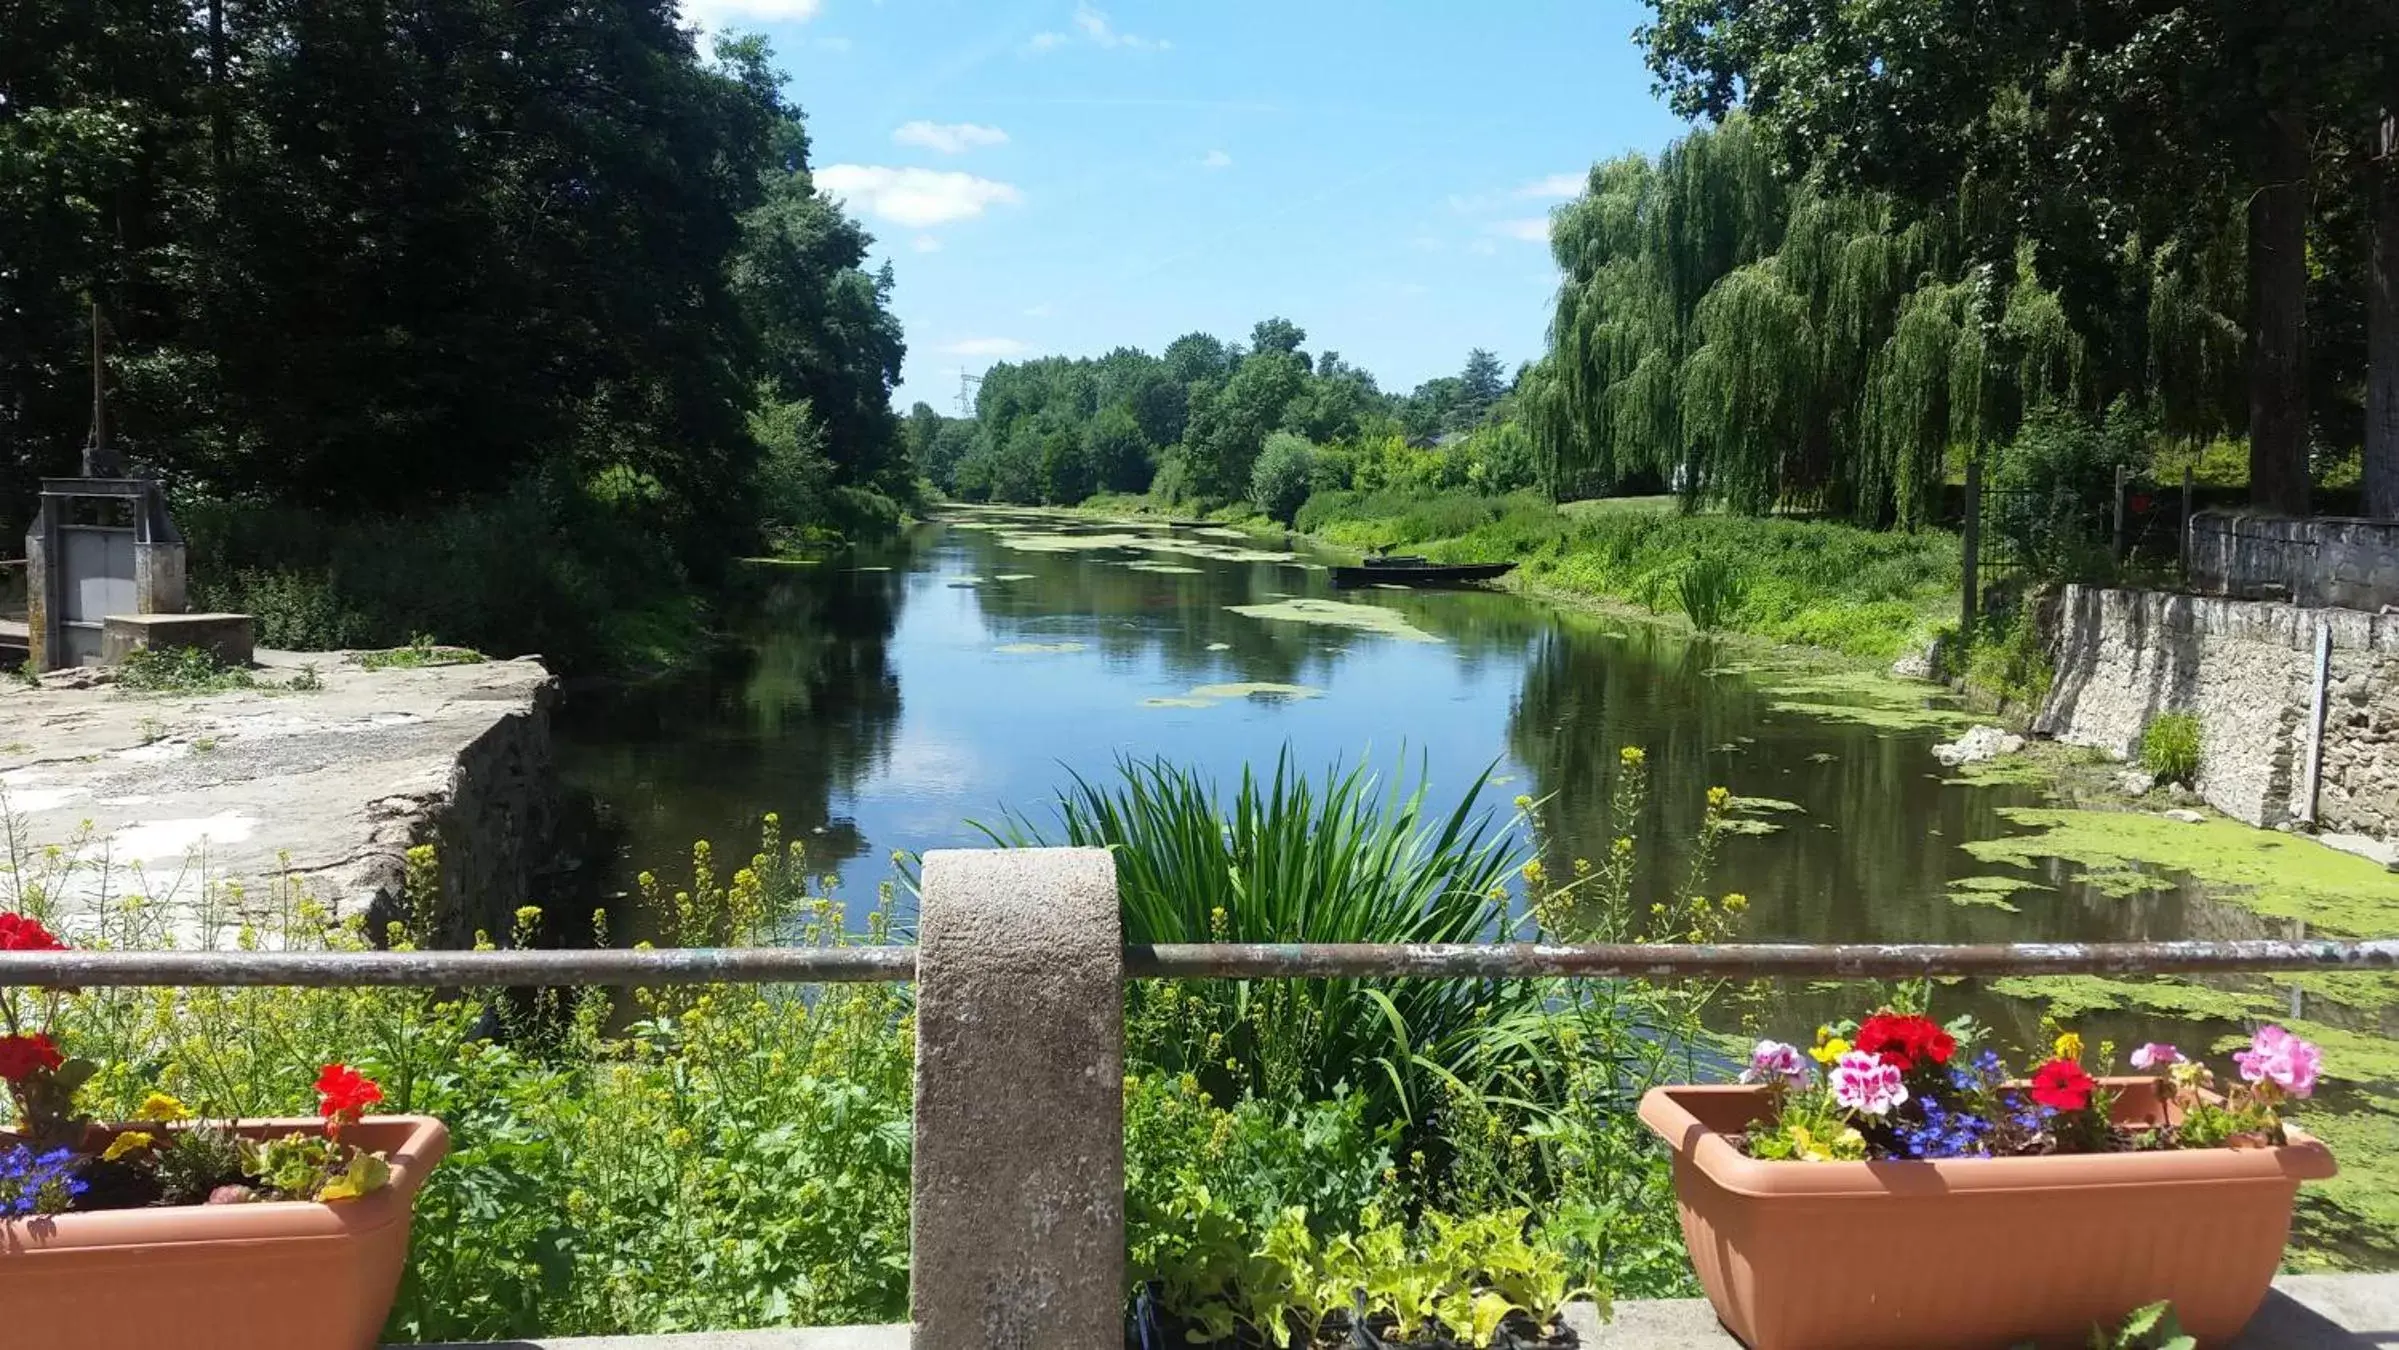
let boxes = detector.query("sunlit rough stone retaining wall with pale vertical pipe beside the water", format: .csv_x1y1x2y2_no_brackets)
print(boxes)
2034,585,2399,839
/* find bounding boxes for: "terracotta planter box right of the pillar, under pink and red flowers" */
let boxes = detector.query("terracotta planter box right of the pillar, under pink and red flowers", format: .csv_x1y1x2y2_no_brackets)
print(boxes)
1641,1079,2334,1350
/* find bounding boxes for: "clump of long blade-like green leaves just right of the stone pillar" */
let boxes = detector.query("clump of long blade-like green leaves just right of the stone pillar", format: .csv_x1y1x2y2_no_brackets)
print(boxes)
984,753,1540,1125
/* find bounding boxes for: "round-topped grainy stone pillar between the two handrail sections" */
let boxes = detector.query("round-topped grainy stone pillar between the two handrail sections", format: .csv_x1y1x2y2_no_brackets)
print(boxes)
909,849,1125,1350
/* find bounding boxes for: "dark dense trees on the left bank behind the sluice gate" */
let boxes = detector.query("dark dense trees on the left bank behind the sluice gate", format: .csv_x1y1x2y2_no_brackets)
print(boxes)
0,0,914,671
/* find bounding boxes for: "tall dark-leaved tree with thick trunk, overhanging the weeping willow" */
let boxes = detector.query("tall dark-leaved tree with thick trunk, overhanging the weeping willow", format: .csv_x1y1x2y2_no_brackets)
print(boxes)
1643,0,2358,511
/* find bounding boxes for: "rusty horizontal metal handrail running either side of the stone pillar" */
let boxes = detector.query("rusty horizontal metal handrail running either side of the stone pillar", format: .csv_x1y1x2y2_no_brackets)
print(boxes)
0,940,2399,988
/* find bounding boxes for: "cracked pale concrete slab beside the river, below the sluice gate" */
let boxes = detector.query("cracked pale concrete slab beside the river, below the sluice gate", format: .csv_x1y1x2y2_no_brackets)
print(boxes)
0,652,557,926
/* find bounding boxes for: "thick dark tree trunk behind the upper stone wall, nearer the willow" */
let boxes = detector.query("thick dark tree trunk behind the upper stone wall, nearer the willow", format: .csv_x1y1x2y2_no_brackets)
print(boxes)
2248,101,2308,516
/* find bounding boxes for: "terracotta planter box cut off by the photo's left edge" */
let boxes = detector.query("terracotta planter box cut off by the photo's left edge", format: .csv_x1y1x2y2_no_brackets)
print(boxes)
0,1115,449,1350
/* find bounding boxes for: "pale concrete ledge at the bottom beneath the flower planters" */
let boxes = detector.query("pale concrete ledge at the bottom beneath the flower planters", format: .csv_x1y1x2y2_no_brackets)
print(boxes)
417,1276,2399,1350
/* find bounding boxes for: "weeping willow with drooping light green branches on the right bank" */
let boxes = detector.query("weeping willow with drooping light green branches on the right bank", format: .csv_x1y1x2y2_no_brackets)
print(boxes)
1526,115,2241,525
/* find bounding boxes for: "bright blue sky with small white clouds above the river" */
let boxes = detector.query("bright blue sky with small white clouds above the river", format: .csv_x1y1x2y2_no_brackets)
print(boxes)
684,0,1682,412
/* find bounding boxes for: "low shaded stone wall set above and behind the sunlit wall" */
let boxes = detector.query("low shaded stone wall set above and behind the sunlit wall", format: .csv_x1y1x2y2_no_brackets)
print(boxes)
2190,511,2399,611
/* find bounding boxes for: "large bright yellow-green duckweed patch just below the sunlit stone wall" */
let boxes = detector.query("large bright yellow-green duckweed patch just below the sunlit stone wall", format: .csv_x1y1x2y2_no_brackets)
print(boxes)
1965,806,2399,935
